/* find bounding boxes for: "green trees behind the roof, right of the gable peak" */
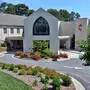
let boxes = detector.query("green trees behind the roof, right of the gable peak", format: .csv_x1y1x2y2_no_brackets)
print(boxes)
47,9,80,21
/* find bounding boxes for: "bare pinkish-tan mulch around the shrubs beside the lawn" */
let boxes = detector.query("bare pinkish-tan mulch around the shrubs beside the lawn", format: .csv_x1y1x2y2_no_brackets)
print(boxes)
1,69,75,90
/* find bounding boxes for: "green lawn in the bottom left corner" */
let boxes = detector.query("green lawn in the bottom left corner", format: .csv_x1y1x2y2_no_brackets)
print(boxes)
0,71,32,90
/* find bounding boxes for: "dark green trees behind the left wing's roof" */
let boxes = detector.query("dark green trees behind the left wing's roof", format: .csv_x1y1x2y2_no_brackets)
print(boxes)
0,2,34,16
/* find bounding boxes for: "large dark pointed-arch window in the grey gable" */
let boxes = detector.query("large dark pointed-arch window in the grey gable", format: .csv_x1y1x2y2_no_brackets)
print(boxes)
33,17,50,35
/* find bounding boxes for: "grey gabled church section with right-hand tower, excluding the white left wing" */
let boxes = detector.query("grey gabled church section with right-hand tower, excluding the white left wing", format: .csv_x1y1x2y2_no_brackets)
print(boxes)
23,8,89,52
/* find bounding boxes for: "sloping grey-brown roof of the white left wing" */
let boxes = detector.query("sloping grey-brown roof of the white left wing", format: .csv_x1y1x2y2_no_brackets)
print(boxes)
0,13,26,26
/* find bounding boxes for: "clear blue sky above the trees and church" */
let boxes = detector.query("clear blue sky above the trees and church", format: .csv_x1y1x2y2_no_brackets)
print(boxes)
3,0,90,18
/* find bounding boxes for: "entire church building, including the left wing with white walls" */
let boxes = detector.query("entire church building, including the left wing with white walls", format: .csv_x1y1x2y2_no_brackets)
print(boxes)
0,8,90,52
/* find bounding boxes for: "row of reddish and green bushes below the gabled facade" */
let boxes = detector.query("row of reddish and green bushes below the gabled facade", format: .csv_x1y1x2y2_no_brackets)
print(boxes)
15,49,68,61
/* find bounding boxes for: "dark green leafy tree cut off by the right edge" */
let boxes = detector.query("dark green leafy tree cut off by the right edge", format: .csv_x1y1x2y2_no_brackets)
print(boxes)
81,29,90,65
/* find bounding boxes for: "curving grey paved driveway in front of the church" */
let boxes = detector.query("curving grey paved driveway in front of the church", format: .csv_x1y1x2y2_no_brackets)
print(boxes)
0,54,90,90
